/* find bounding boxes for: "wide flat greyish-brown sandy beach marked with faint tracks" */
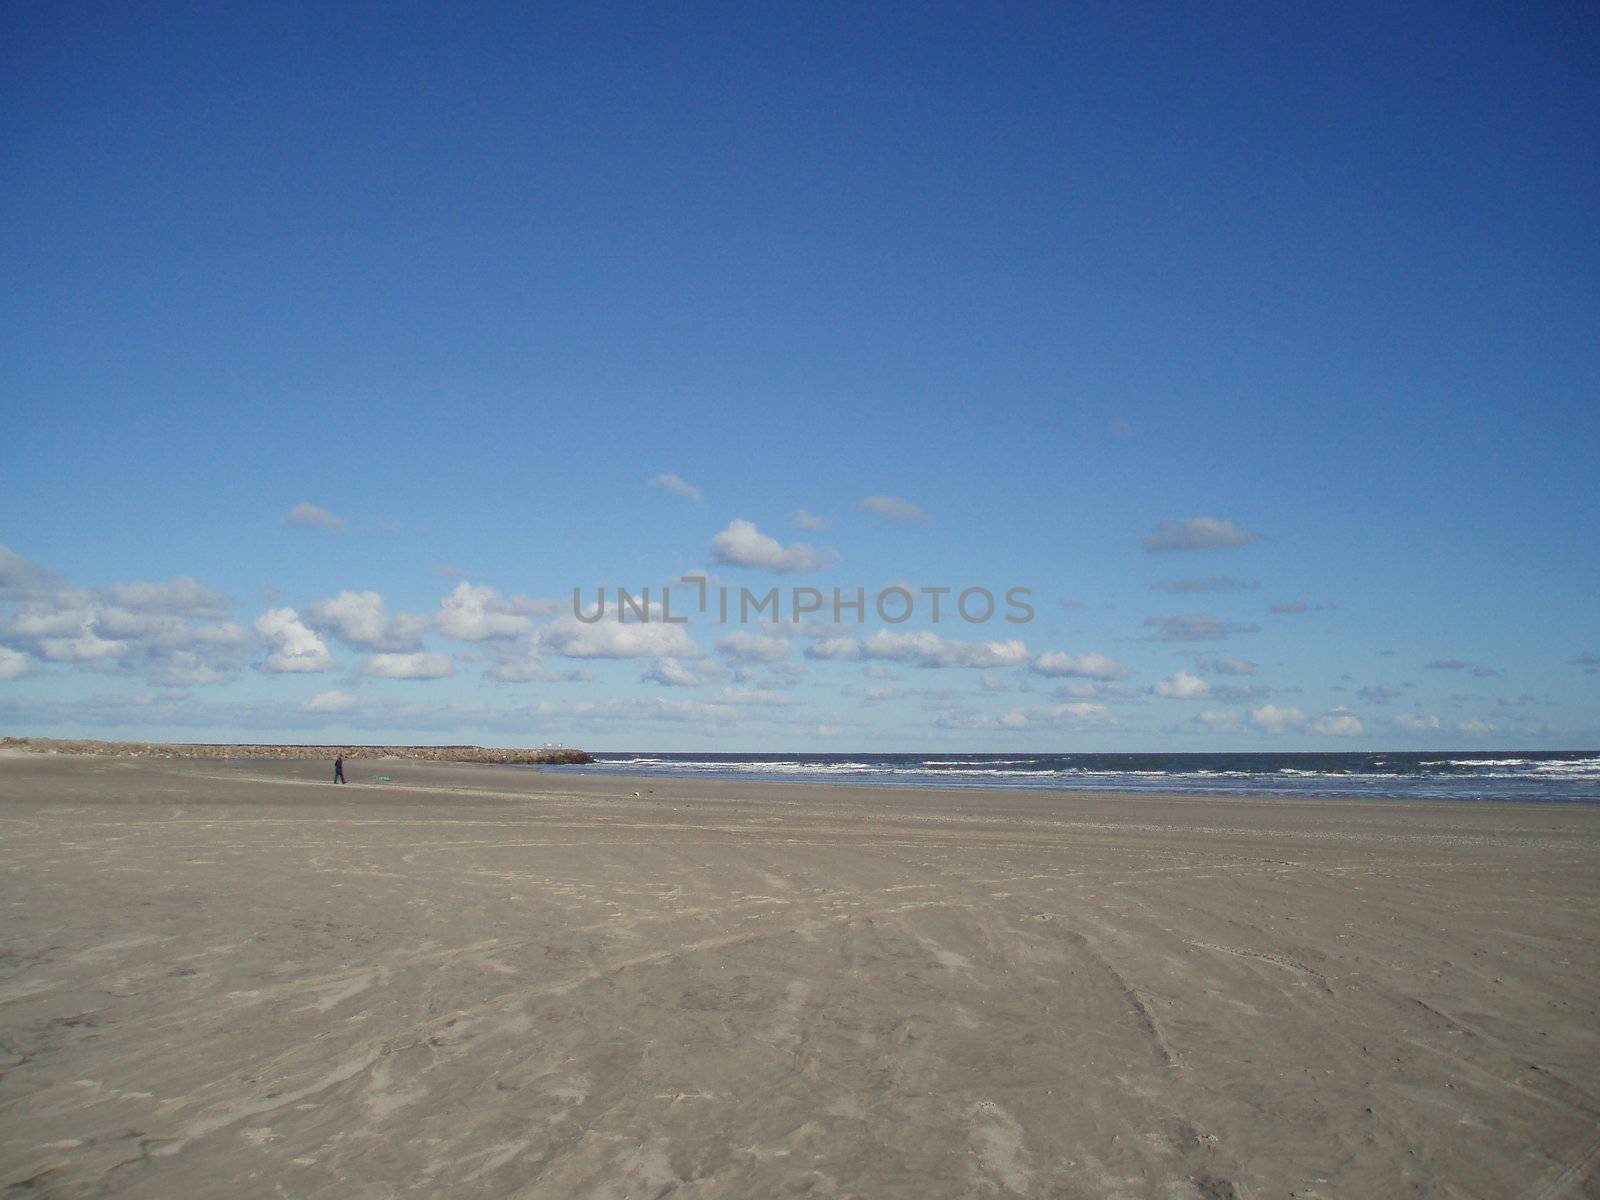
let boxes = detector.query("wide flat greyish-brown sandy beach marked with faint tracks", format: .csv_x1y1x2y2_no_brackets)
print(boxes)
0,755,1600,1200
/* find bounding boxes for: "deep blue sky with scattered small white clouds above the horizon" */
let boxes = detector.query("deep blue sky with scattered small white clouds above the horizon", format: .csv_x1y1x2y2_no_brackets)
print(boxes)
0,5,1600,750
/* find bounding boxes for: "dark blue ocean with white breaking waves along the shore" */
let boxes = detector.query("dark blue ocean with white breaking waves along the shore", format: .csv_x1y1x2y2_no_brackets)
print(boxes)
562,750,1600,803
